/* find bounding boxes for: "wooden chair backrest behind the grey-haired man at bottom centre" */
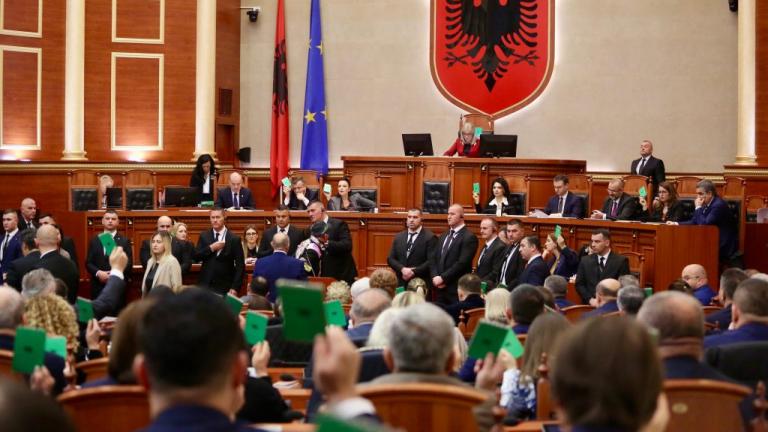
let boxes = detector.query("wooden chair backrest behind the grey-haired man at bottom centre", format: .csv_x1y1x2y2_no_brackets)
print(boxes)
357,383,486,432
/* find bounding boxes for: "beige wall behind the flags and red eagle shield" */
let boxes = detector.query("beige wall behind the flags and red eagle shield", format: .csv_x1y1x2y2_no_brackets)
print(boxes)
240,0,737,172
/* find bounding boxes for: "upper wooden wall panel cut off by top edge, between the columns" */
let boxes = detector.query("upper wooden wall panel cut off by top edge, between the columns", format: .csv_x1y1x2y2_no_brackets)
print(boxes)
112,0,164,40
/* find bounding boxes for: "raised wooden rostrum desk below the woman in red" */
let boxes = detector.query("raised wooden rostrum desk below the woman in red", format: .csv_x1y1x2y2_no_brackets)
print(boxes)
341,156,587,211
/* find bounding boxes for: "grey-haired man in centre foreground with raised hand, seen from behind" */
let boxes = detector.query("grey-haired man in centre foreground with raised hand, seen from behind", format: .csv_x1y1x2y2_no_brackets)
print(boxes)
366,303,503,430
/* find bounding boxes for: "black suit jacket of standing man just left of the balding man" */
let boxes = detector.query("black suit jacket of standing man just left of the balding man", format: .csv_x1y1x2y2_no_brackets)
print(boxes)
387,227,437,287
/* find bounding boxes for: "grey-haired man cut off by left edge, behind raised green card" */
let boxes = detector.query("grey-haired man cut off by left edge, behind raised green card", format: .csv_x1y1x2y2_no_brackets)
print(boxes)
0,286,67,394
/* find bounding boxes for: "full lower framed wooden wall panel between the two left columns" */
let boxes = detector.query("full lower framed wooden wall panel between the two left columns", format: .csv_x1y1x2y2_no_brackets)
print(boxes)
112,53,163,148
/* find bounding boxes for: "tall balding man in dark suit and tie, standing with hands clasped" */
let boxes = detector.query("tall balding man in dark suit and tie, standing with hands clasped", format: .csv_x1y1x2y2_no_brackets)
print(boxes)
430,204,477,305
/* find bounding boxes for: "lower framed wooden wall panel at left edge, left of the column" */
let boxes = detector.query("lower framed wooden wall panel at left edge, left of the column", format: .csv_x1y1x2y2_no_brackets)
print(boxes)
0,47,41,147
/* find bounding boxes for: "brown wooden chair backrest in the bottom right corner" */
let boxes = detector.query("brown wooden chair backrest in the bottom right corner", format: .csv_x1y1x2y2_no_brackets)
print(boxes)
664,380,750,432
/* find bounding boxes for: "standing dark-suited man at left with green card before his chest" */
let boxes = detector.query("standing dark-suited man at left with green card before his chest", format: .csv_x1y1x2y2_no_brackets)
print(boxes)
85,210,133,298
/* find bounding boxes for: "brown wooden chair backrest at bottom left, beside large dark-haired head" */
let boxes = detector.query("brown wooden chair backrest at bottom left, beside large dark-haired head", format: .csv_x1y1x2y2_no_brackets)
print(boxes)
58,386,150,432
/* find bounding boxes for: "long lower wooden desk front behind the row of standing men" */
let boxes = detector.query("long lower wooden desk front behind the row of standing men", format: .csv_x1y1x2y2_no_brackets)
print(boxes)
82,210,718,290
